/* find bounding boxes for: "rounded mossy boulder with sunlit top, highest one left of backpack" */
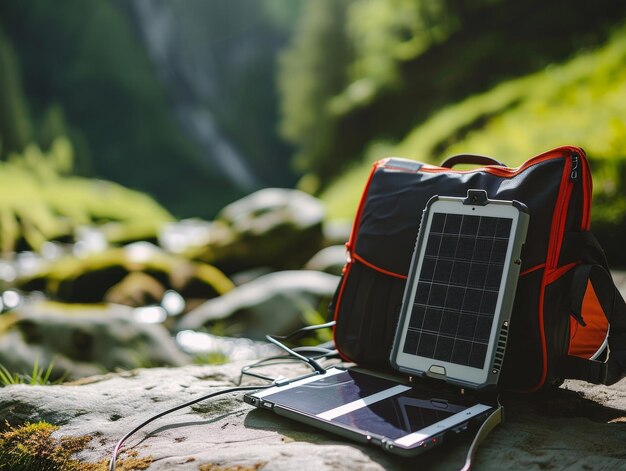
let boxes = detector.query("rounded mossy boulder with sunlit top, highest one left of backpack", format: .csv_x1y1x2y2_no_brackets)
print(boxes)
197,188,324,273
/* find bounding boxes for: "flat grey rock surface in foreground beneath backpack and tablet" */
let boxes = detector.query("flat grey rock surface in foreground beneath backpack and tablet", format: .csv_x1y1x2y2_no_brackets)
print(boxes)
0,364,626,471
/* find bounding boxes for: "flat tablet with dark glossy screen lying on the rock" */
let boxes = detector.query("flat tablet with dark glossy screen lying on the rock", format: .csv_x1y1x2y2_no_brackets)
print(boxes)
244,368,494,456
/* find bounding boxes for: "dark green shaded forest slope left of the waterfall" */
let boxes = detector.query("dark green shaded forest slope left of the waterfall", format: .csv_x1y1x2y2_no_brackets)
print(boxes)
0,0,258,216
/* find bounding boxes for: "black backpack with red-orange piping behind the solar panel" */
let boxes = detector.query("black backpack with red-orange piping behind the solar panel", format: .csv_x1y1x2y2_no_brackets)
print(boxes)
331,147,626,392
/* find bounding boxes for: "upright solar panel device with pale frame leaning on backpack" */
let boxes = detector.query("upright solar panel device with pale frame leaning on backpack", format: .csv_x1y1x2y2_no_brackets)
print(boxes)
390,190,528,389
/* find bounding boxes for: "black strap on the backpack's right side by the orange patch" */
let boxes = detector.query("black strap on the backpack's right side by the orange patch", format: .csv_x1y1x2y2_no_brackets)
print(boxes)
559,232,626,385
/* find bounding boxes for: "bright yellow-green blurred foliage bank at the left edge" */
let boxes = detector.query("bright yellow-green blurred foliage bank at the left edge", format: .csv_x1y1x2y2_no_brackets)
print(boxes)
0,138,172,254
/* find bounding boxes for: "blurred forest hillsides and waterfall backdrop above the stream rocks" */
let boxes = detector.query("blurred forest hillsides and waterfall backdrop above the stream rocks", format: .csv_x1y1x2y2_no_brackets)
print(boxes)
0,0,626,266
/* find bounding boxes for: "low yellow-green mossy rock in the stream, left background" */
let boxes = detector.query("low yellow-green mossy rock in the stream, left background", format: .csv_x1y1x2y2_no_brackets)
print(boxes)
18,242,233,306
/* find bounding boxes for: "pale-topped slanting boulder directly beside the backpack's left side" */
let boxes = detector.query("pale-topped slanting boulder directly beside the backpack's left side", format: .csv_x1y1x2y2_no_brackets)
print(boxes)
176,270,339,339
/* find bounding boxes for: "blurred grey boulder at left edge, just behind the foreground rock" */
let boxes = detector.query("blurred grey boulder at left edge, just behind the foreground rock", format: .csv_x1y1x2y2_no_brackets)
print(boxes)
0,303,191,379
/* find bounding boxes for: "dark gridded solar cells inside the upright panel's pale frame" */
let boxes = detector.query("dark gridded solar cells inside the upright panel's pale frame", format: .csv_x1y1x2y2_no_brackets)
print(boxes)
403,213,512,368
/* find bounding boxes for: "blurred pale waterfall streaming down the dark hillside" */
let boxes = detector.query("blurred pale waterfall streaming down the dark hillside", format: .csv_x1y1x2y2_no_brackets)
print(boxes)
132,0,260,190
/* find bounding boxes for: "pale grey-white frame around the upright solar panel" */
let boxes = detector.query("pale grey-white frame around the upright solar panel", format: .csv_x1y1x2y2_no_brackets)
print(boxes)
391,197,522,387
